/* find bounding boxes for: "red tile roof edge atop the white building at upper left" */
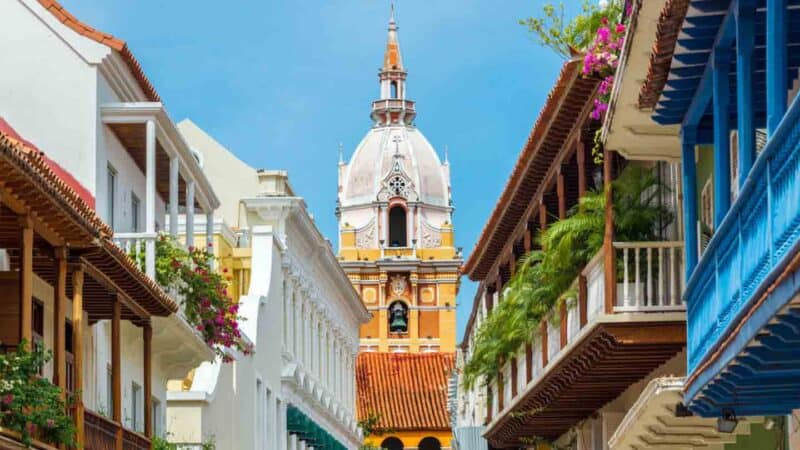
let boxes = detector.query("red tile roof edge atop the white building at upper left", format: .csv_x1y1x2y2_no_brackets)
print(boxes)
38,0,161,102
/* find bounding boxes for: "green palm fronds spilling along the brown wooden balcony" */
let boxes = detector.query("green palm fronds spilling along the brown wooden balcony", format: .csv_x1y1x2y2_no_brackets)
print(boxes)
463,165,672,388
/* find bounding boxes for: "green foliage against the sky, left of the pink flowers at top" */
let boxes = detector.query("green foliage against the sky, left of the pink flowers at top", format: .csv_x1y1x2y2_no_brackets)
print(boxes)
519,0,622,59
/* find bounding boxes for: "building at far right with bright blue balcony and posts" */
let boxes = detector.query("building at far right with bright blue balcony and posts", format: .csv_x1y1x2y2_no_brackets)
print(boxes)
603,0,800,450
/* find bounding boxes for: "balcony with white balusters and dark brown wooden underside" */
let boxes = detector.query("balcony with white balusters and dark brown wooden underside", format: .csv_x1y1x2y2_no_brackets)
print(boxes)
485,242,686,448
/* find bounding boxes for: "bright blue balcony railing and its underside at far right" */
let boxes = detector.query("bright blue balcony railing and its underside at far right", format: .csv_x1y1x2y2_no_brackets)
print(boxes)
686,92,800,416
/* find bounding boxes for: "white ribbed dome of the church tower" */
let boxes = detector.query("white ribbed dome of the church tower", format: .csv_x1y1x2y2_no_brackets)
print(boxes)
339,125,450,207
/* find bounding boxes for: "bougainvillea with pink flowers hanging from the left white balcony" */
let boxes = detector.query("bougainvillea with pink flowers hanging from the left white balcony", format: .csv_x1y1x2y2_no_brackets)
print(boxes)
156,235,252,362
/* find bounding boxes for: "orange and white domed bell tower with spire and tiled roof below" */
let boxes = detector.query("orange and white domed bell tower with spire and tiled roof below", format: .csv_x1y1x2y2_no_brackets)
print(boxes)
337,7,461,450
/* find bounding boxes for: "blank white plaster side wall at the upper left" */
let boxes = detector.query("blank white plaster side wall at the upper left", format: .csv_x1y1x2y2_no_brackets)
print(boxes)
0,0,110,192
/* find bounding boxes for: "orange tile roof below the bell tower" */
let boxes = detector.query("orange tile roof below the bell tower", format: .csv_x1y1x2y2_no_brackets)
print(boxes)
356,353,455,431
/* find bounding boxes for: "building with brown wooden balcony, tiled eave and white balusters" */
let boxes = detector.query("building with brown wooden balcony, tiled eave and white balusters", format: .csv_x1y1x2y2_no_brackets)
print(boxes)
455,59,685,450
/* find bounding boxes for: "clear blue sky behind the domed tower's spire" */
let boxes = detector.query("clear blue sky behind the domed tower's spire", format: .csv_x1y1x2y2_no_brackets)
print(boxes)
61,0,577,340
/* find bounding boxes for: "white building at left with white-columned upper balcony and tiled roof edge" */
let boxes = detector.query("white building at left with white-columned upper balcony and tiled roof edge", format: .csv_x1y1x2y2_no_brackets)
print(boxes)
0,0,219,440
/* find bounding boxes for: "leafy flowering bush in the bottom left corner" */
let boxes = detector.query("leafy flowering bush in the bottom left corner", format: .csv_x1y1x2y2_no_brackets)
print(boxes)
0,341,76,446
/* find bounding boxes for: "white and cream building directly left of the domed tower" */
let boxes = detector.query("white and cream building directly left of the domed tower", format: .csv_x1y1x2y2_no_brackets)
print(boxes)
168,120,369,450
